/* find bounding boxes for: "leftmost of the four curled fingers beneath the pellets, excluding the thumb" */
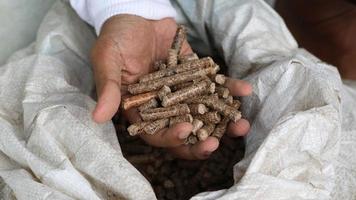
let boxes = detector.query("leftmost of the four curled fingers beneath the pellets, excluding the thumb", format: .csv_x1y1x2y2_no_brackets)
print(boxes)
141,122,193,147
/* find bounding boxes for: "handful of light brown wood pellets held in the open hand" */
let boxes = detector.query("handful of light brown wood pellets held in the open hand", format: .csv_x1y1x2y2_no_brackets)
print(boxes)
122,26,241,144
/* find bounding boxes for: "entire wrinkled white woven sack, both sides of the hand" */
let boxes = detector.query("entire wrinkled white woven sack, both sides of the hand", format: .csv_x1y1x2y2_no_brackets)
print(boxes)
0,0,356,200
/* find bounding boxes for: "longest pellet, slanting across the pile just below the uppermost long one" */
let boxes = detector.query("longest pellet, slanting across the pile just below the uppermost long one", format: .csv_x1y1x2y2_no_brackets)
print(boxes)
127,67,219,94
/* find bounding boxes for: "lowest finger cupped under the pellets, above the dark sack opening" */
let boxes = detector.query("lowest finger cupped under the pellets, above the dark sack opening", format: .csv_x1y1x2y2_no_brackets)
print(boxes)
170,137,219,160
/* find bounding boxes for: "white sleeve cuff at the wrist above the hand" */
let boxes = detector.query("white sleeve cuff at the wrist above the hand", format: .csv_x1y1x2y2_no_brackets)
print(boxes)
70,0,176,34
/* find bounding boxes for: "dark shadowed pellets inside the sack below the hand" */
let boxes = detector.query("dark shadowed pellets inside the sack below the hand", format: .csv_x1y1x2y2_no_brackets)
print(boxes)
113,115,244,200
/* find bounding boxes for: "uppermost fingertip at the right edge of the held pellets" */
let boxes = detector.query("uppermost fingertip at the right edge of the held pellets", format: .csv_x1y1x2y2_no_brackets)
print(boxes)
225,78,252,96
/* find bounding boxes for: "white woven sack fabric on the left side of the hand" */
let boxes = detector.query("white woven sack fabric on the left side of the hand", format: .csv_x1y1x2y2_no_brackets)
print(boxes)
0,1,155,200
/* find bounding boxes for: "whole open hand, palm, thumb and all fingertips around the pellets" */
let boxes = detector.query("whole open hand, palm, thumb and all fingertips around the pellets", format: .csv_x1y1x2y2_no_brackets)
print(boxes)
92,15,252,159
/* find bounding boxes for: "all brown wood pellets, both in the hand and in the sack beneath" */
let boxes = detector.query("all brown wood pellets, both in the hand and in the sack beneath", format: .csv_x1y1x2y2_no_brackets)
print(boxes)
113,26,244,200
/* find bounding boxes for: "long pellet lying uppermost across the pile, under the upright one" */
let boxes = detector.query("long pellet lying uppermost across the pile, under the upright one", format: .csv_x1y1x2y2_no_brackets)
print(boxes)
139,57,214,83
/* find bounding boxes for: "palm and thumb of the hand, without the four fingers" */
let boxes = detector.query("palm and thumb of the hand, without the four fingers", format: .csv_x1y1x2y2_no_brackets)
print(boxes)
92,14,192,123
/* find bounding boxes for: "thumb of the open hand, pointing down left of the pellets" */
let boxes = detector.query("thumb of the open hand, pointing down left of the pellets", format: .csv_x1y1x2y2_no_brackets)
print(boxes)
92,39,123,123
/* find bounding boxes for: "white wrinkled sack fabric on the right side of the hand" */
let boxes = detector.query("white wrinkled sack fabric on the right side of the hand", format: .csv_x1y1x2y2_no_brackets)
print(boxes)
176,0,356,200
